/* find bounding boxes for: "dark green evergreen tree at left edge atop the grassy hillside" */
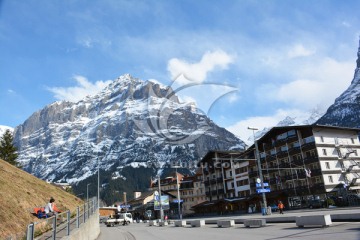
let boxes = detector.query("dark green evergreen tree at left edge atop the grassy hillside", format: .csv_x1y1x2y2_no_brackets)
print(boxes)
0,129,20,167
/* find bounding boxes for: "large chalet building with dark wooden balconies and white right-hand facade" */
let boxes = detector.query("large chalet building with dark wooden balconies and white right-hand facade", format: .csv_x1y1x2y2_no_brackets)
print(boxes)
249,125,360,207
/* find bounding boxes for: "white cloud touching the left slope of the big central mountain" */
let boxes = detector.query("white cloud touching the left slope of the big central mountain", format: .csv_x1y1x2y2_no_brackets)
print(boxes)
48,75,111,102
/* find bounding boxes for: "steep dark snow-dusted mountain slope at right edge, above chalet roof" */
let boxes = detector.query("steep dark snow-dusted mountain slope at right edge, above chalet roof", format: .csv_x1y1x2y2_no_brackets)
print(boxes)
316,41,360,128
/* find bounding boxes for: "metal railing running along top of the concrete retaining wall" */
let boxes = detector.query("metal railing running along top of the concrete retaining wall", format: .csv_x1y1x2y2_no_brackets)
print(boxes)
26,198,98,240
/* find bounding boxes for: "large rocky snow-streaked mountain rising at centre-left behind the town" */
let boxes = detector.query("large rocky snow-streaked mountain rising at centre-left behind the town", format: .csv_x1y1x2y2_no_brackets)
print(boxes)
14,75,245,183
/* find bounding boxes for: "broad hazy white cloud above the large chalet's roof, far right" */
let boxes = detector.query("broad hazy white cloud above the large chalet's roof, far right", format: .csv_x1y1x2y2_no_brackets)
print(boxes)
257,58,354,109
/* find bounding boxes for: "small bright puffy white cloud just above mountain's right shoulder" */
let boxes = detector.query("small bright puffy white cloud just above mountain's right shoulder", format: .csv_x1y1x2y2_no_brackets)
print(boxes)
167,50,233,85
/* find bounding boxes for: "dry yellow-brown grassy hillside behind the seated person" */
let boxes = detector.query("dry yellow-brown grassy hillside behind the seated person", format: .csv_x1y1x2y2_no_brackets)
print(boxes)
0,160,82,239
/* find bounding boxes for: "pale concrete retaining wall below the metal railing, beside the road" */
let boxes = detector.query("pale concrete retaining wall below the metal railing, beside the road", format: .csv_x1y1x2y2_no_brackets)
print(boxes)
61,210,100,240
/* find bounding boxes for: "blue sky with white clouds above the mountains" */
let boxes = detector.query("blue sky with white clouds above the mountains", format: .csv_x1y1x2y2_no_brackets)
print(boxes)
0,0,360,141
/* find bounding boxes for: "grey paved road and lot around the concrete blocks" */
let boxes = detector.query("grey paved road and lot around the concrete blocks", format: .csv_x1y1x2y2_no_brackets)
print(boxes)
98,209,360,240
